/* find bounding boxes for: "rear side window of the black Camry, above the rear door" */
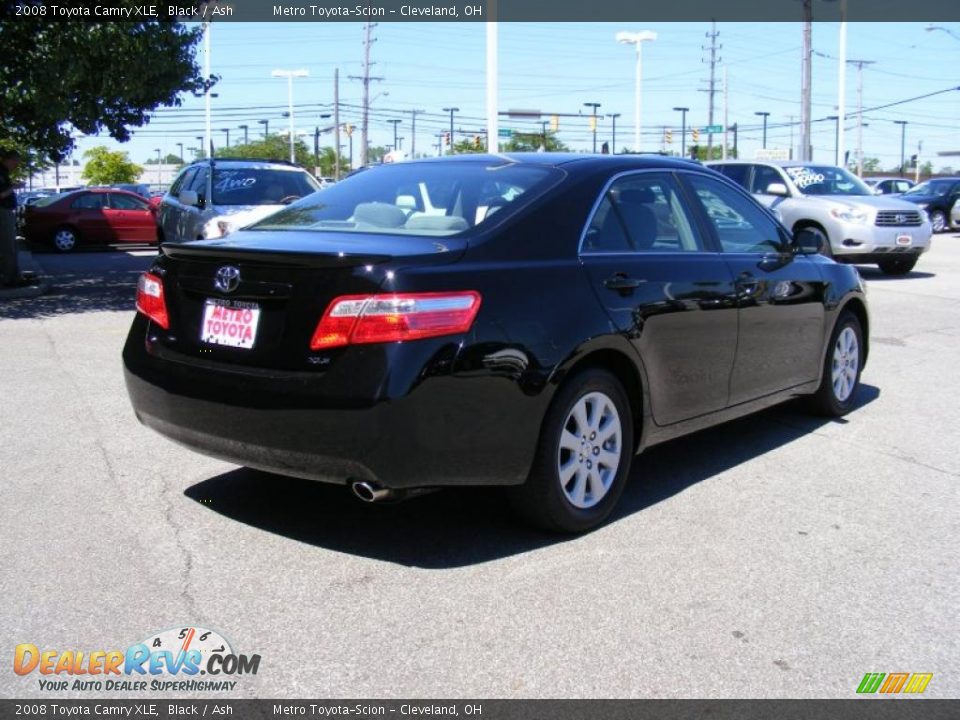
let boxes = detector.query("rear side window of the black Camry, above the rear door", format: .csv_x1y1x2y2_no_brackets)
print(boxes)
582,173,703,253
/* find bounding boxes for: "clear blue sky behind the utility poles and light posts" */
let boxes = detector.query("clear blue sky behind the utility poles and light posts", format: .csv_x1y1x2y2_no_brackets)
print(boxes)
71,22,960,169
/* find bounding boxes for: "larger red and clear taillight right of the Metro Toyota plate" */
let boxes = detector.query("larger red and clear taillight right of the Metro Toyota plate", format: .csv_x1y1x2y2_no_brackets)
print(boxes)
310,291,480,350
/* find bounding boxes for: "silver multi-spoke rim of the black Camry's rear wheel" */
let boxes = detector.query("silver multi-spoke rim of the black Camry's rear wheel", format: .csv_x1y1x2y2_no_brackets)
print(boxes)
557,392,623,509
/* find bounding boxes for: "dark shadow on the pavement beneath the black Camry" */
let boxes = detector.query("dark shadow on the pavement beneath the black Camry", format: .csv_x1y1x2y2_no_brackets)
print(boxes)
184,385,880,569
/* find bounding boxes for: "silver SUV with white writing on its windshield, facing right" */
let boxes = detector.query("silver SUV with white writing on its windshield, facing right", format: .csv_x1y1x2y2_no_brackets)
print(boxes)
707,160,933,275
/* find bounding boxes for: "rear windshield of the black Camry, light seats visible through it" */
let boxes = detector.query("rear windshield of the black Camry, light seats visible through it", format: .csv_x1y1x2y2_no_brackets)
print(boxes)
248,160,561,236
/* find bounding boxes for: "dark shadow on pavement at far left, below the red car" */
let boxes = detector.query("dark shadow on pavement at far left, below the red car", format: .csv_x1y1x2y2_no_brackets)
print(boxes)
0,250,153,319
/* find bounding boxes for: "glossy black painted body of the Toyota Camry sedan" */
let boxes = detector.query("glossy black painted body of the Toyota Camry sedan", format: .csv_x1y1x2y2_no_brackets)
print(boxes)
124,155,868,488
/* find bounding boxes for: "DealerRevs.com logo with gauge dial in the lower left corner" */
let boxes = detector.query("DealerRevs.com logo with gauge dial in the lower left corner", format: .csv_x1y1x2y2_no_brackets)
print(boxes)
13,627,260,692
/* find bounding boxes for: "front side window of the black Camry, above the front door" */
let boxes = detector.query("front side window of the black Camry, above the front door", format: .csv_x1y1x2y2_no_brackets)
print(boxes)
689,175,783,253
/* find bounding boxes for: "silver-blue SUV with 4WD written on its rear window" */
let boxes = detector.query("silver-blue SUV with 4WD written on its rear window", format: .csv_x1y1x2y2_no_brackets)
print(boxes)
157,158,320,242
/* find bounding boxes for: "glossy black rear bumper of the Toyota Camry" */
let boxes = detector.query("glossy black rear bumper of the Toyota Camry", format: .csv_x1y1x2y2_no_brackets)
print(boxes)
124,317,550,489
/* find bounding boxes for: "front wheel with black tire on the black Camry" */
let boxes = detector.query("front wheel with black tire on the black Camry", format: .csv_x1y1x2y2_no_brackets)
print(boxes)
811,310,863,417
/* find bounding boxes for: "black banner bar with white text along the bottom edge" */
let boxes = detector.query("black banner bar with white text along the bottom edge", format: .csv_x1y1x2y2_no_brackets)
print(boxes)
0,697,960,720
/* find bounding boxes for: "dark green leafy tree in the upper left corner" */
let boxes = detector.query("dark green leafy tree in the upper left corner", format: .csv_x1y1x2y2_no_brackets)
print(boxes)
0,10,208,160
